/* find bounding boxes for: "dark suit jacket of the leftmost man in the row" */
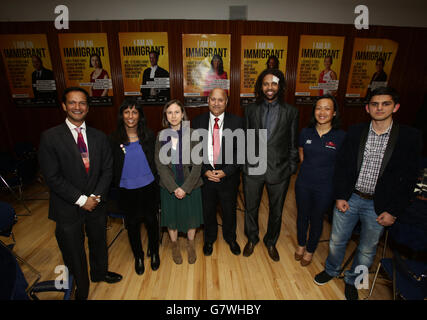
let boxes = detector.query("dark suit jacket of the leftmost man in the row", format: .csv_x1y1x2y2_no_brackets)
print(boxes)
39,123,113,223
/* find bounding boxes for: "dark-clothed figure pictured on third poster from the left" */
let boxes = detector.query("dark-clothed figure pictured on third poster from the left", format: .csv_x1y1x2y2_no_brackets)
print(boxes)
141,51,170,99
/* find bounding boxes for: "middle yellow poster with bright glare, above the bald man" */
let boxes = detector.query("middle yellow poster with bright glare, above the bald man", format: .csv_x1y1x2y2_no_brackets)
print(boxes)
182,34,231,107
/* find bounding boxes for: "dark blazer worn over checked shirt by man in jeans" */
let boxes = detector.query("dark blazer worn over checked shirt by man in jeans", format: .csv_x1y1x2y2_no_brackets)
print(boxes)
334,121,422,217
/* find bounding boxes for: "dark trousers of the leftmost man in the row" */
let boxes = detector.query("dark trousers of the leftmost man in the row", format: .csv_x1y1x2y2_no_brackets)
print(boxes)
55,212,108,299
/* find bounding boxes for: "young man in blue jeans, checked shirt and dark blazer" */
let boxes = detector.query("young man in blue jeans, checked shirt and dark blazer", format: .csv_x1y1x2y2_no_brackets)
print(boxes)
314,87,421,300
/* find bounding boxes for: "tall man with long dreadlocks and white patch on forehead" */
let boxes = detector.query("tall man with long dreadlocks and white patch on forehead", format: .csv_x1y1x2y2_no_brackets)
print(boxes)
243,69,299,261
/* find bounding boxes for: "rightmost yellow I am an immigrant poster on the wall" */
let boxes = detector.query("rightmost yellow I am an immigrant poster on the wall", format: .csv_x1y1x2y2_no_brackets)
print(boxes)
345,38,399,105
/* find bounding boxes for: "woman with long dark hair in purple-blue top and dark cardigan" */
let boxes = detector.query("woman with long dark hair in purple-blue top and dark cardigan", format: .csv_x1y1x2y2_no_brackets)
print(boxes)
110,99,160,275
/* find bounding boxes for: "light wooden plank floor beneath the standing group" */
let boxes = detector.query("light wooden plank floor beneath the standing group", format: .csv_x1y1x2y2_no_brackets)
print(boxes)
1,176,392,300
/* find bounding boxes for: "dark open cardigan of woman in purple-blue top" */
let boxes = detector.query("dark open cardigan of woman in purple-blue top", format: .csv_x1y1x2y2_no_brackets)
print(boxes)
108,129,158,187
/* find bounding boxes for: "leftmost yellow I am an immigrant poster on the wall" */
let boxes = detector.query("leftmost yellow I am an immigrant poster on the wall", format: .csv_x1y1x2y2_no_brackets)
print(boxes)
0,34,58,107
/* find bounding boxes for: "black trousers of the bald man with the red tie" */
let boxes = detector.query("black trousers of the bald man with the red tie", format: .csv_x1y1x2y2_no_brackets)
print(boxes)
202,174,240,243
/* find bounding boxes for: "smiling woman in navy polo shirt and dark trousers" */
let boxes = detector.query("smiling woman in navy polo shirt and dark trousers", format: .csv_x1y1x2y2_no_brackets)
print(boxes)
295,95,345,266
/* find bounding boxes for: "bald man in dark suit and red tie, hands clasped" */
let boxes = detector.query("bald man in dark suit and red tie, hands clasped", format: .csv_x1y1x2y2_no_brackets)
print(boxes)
192,88,243,256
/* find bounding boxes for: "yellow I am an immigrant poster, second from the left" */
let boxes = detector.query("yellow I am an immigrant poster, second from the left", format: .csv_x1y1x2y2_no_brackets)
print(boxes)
58,33,113,106
